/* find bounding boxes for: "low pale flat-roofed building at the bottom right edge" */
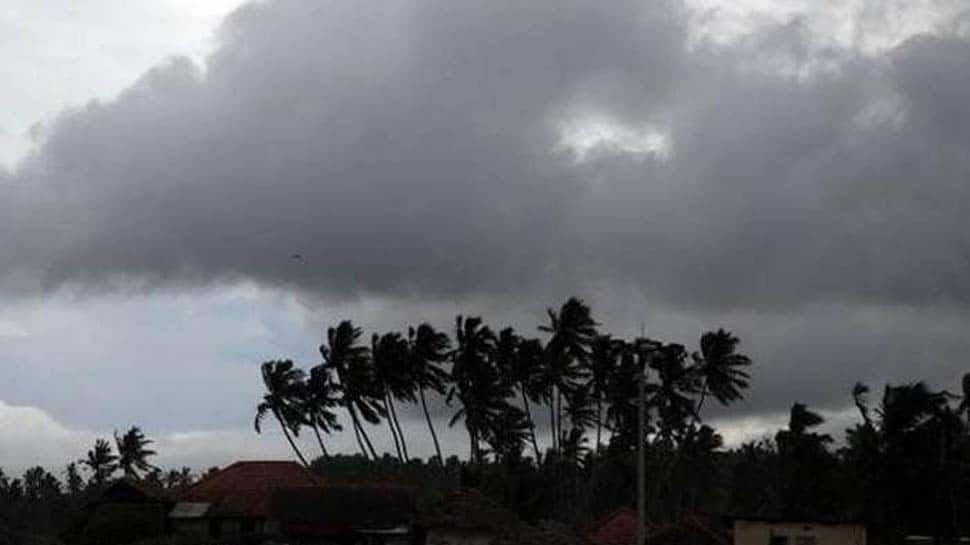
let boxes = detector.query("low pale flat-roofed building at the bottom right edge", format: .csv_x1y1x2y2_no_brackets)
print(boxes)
733,518,866,545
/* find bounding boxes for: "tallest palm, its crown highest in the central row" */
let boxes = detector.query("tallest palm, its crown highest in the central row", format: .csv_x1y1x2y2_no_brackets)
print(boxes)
539,297,597,450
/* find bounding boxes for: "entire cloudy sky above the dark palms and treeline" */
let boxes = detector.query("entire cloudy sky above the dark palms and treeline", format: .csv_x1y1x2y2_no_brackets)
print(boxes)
0,0,970,471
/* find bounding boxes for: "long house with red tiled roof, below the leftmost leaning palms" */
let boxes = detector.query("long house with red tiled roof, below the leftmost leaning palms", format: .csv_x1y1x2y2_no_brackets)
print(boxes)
168,462,414,545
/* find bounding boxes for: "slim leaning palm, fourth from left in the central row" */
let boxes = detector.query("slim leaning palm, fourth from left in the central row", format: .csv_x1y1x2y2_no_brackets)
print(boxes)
371,332,414,462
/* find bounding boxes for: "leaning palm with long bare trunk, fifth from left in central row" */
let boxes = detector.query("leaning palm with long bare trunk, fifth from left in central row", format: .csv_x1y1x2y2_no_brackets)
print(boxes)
407,323,451,464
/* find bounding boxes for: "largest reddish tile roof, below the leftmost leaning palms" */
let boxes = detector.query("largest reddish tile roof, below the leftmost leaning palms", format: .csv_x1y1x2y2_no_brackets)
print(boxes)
178,462,324,517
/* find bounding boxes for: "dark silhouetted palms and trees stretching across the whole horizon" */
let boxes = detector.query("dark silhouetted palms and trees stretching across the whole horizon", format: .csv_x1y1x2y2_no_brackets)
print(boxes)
0,299,970,541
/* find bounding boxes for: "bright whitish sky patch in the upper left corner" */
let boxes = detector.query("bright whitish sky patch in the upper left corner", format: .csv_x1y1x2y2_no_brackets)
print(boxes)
0,0,243,168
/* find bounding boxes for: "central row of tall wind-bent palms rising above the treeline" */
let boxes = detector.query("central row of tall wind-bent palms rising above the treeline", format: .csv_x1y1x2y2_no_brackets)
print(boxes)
254,298,751,464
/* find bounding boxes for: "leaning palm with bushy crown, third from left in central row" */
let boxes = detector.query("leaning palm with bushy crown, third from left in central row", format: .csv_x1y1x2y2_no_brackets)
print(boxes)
320,320,385,460
